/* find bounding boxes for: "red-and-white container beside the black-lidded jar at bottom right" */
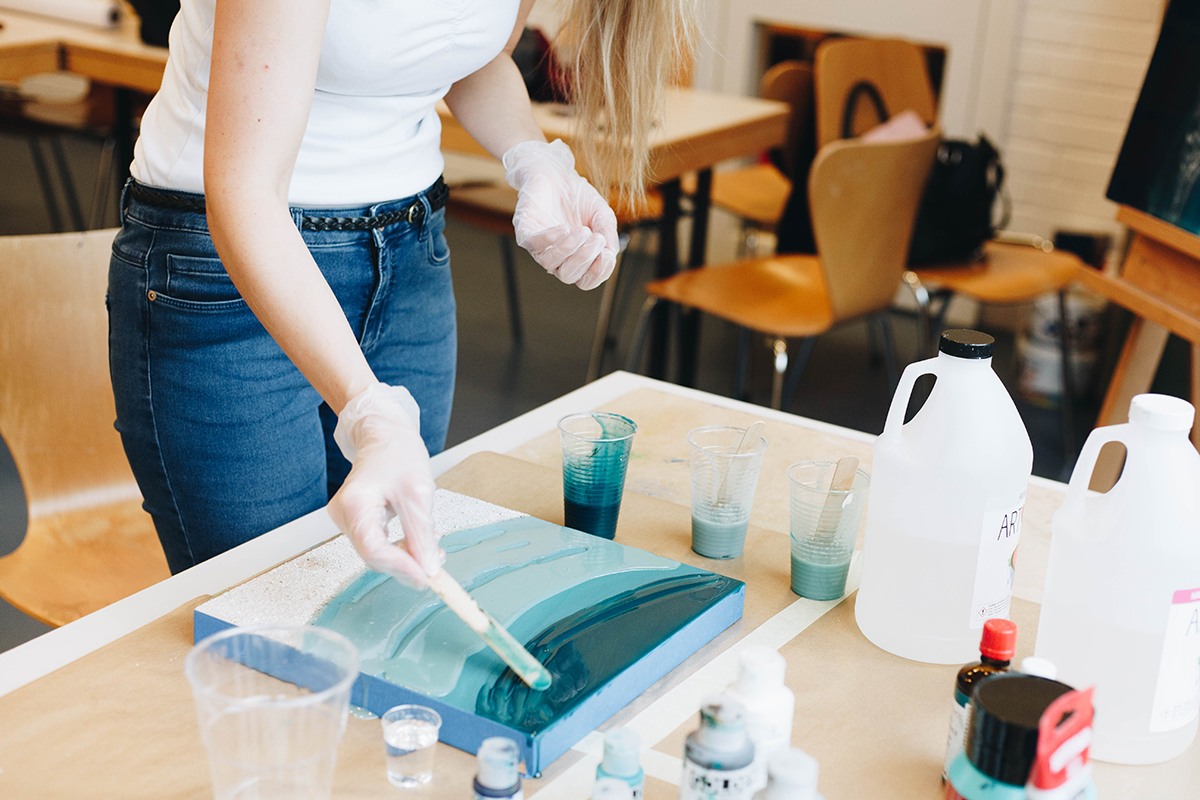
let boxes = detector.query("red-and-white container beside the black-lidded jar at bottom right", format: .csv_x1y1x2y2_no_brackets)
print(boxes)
1025,688,1096,800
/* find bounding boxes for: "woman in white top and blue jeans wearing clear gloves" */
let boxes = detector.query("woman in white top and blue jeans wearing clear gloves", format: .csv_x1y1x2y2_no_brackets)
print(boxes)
109,0,690,585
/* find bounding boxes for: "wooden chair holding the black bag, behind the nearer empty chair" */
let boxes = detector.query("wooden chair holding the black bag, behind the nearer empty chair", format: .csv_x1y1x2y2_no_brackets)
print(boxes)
815,38,1082,463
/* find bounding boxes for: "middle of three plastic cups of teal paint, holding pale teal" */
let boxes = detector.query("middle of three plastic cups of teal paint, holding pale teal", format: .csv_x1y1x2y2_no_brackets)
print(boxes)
688,425,767,559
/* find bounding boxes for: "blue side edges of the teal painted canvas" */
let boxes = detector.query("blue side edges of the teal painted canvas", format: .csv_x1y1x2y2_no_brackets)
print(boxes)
193,582,745,776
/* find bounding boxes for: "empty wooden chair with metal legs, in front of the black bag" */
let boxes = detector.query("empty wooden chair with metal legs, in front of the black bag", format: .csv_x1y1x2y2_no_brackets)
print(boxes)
630,128,940,408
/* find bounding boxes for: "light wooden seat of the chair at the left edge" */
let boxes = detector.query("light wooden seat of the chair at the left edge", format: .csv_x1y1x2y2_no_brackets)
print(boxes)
0,499,170,626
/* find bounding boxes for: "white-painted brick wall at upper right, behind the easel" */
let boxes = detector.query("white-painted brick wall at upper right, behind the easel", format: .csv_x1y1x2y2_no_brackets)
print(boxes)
1004,0,1161,236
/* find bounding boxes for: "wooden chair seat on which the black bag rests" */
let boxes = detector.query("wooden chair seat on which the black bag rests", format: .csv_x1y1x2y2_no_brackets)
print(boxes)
913,242,1082,302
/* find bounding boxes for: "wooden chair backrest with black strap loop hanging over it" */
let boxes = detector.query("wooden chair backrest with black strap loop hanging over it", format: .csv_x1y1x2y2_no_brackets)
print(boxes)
812,38,937,148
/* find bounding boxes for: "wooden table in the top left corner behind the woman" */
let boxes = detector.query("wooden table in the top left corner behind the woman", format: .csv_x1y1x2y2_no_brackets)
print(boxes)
0,10,167,184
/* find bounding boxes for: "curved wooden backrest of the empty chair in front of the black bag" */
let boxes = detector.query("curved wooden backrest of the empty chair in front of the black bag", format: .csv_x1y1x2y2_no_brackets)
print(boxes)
809,127,941,320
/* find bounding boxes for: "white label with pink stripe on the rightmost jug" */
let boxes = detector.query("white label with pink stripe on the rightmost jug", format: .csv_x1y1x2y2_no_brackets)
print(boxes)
1150,589,1200,733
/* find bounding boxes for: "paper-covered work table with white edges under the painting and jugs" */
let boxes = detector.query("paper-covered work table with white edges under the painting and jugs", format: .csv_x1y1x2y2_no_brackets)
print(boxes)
0,373,1185,800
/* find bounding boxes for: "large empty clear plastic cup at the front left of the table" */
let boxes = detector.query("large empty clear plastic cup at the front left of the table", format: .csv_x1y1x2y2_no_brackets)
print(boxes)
184,626,359,800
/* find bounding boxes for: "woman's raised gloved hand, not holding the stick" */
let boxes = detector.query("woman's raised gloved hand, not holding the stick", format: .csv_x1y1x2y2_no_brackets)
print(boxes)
503,139,617,290
